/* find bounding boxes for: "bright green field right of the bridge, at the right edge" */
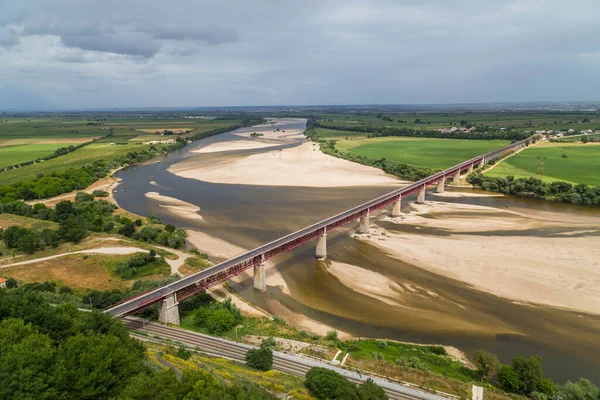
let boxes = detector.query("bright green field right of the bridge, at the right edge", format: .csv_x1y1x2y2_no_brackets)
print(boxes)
486,143,600,186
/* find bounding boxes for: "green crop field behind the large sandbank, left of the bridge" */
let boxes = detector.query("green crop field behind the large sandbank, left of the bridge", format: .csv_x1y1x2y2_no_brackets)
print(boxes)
321,131,509,169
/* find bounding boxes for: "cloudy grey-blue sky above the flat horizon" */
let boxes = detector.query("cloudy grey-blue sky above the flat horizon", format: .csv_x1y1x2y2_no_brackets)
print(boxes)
0,0,600,110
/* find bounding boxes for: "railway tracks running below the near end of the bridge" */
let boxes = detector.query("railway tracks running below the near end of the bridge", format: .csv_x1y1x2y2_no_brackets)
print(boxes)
123,317,451,400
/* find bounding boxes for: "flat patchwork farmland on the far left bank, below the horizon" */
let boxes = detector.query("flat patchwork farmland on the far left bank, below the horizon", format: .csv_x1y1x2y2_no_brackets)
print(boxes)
0,115,245,184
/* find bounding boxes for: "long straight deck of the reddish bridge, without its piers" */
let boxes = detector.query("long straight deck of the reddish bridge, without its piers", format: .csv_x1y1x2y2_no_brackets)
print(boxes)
105,138,532,317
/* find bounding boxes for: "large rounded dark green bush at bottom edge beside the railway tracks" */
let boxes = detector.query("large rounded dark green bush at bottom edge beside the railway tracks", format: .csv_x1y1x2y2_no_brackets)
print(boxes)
304,367,360,400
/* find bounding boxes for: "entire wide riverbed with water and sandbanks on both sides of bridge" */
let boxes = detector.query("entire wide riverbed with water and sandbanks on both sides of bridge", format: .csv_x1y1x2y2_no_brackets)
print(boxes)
114,120,600,381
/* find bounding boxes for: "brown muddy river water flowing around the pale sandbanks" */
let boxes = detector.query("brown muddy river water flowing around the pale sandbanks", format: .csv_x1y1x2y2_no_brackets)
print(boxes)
115,122,600,383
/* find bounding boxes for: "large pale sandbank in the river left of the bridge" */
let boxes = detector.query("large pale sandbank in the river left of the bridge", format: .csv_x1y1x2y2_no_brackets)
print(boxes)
169,118,404,187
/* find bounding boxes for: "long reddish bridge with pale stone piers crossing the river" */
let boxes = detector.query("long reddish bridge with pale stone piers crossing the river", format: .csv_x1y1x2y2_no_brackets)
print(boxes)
105,138,533,325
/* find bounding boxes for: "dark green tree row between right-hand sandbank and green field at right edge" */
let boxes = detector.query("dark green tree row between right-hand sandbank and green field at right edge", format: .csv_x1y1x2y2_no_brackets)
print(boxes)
467,172,600,206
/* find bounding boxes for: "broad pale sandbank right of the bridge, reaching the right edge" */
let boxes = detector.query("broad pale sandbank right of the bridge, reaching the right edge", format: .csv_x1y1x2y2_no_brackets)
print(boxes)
361,202,600,314
